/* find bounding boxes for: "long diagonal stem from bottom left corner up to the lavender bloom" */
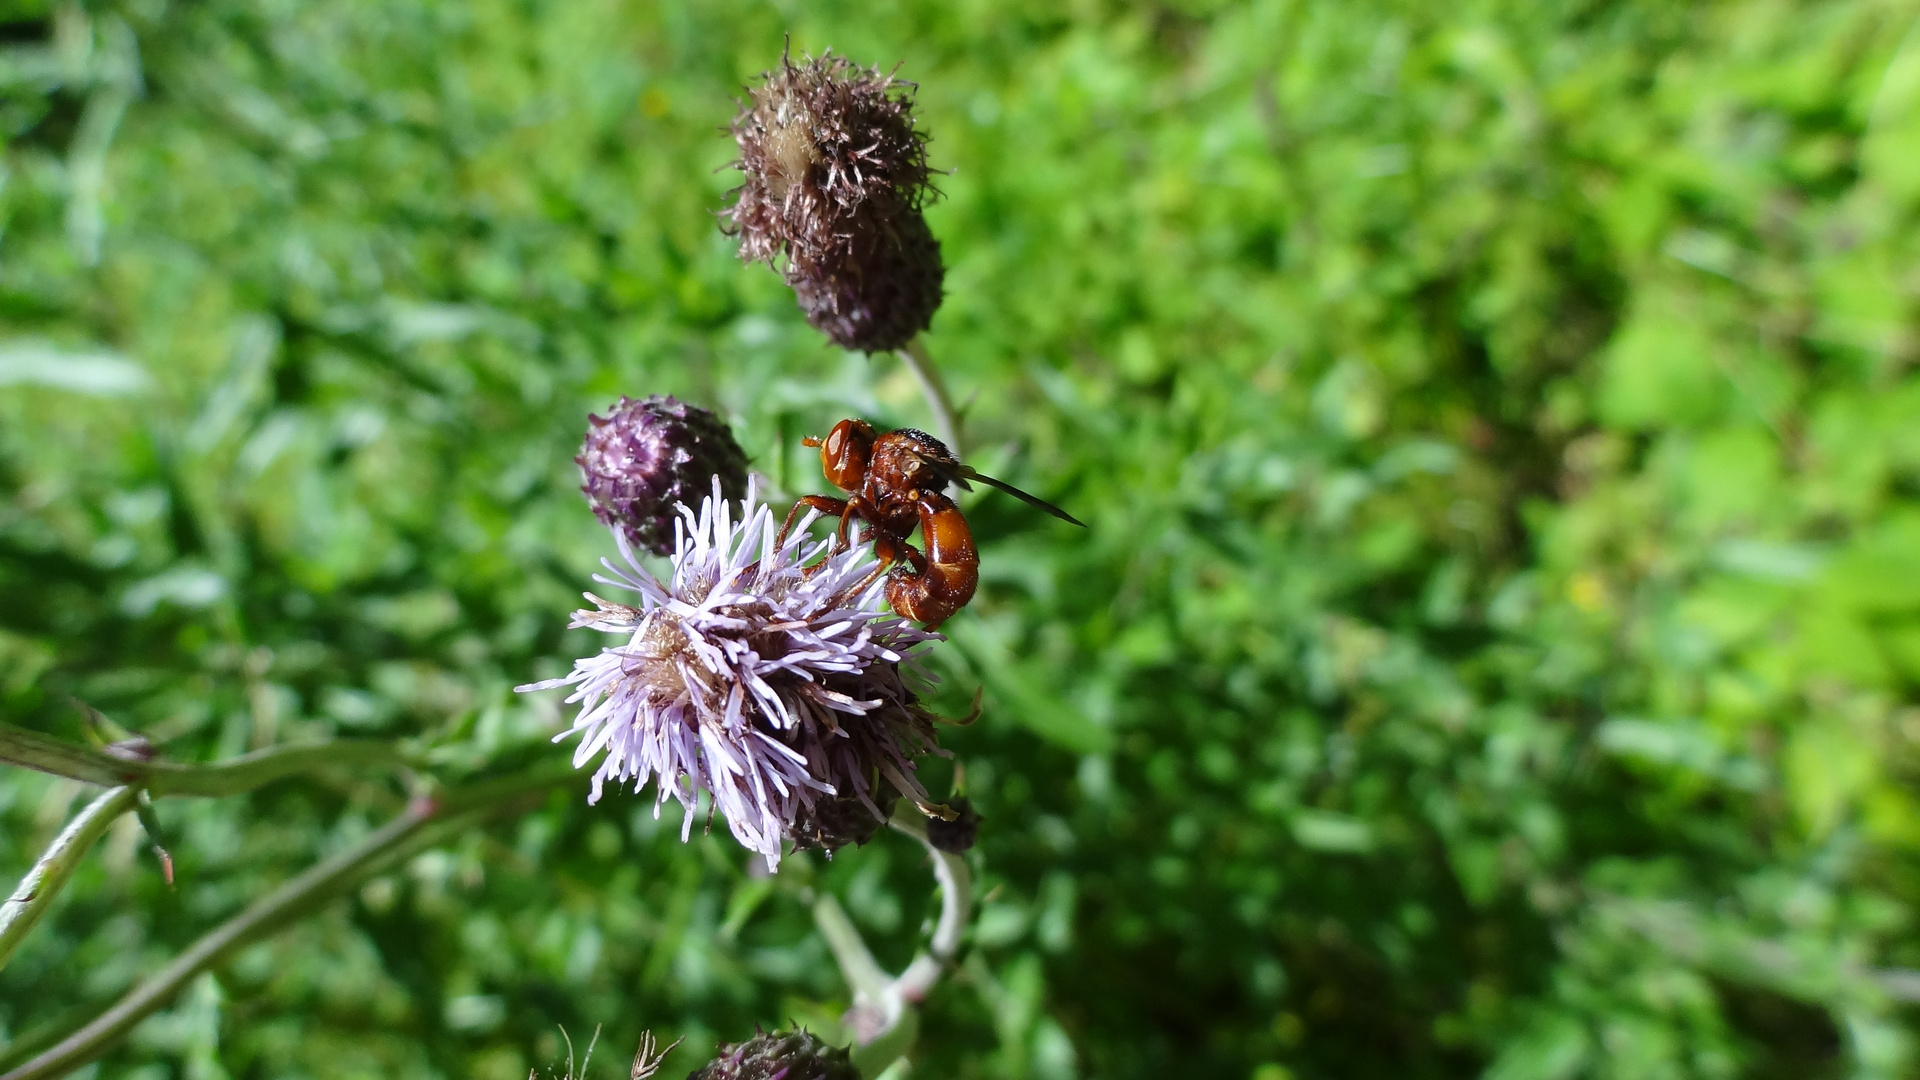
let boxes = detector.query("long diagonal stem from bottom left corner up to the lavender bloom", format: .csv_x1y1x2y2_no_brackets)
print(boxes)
0,769,572,1080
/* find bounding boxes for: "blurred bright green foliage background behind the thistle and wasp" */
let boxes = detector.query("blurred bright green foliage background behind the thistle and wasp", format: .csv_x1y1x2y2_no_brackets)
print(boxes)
0,0,1920,1080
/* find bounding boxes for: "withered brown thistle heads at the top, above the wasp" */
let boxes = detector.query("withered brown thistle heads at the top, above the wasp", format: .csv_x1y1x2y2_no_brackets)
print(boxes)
724,52,943,352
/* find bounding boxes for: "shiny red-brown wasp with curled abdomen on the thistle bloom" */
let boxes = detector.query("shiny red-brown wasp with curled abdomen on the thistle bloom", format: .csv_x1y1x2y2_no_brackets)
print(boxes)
780,419,1085,630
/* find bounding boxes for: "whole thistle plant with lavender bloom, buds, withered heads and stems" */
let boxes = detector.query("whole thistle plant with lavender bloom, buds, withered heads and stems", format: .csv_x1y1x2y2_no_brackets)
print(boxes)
0,42,1013,1080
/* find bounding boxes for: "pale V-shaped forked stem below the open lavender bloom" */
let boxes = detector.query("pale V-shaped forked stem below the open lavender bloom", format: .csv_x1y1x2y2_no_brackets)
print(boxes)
814,809,973,1045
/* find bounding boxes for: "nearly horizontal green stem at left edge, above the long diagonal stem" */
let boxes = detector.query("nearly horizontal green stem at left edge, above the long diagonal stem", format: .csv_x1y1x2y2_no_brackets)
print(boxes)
0,724,405,798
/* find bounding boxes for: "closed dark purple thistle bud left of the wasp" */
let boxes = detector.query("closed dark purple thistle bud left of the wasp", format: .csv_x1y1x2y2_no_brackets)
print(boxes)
574,394,747,555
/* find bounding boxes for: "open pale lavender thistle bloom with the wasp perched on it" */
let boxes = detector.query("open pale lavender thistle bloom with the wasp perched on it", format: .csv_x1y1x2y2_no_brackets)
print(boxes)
516,480,941,867
